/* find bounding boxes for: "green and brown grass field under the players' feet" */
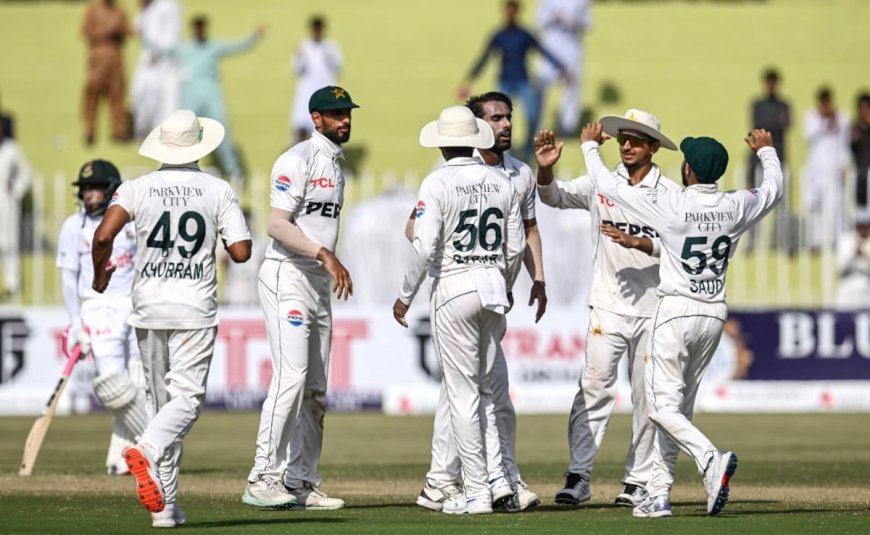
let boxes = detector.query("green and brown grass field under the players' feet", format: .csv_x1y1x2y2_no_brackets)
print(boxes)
0,411,870,534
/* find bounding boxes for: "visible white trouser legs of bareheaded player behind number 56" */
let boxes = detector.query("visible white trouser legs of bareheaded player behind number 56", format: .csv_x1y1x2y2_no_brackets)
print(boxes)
426,344,521,488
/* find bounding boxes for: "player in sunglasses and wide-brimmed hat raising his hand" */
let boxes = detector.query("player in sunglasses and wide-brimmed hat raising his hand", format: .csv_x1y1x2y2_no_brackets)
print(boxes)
535,109,680,507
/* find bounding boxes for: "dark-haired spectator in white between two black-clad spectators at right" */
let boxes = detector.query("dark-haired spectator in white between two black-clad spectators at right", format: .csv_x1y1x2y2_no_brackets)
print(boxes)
802,87,849,250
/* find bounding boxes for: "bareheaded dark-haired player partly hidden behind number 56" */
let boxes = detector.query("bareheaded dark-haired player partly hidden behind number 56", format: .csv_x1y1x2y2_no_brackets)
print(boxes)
414,91,547,512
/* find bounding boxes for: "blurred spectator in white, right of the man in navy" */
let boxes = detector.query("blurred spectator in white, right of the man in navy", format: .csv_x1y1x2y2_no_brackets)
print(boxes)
538,0,592,135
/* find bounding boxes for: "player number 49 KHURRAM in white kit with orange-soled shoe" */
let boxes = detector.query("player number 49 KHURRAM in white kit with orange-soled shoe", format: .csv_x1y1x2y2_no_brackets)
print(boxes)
93,110,251,528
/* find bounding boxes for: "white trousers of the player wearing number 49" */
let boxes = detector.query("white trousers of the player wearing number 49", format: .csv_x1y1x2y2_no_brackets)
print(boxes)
136,327,217,504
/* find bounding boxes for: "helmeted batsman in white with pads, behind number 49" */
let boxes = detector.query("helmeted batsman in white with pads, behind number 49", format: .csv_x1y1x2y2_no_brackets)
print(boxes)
57,160,148,475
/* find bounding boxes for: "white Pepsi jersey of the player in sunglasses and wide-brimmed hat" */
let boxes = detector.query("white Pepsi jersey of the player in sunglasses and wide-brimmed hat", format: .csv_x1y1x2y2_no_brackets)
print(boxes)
538,164,680,318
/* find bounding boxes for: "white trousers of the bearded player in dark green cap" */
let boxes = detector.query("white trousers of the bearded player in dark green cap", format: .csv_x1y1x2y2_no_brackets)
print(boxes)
254,259,332,488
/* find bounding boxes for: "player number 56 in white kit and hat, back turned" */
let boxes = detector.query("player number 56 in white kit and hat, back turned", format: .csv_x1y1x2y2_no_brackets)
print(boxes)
393,106,525,514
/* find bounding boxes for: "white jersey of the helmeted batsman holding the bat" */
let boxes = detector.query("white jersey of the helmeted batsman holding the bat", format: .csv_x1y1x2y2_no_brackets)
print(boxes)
57,212,136,299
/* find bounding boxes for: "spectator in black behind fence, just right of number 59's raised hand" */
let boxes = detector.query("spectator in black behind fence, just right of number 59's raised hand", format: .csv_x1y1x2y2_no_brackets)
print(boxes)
744,68,791,250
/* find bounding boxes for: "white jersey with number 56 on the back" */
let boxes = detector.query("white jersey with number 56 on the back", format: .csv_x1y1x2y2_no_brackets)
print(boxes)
400,158,525,304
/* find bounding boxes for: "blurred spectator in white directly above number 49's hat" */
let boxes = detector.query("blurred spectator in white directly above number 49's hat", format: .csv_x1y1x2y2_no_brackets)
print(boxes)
130,0,181,139
